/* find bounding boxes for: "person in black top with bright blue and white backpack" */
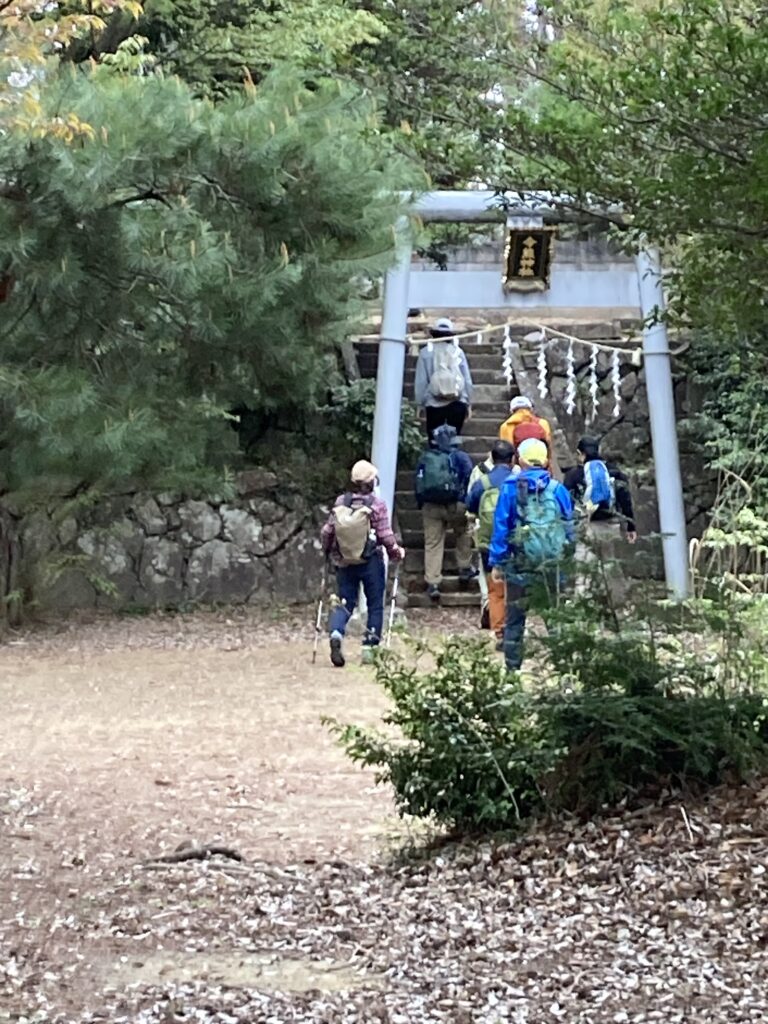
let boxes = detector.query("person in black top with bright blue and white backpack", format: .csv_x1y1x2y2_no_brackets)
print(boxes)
563,437,637,597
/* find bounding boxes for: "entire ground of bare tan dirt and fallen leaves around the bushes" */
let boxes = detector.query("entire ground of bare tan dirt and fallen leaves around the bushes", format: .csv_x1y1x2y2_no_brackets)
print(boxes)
0,612,768,1024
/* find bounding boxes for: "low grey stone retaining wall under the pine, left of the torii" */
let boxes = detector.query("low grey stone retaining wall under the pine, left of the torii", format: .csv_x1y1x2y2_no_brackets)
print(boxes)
9,471,322,612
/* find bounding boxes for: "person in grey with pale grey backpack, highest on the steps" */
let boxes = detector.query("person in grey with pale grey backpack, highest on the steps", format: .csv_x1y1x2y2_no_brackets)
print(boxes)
414,316,472,438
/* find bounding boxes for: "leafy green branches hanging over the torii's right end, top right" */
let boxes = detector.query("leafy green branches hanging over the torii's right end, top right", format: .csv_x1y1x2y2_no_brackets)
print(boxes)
504,0,768,331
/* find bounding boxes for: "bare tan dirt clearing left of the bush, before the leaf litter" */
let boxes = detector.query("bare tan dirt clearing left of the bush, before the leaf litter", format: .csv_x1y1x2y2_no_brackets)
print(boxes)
0,617,403,876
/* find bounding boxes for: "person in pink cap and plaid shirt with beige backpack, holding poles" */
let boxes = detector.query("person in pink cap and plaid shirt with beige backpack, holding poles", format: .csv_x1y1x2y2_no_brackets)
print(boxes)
321,460,406,669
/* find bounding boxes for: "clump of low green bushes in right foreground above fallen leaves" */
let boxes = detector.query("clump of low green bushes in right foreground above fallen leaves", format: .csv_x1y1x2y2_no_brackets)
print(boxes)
334,595,768,830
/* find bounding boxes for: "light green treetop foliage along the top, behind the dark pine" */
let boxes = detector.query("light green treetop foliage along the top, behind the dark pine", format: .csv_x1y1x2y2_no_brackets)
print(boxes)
75,0,520,188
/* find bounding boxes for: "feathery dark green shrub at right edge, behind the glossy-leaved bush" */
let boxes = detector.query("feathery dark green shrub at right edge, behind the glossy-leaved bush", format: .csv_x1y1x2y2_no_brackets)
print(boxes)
540,592,768,812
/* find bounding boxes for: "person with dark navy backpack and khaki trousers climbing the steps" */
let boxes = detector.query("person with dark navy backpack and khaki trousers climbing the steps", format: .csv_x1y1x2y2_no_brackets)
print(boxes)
415,424,477,603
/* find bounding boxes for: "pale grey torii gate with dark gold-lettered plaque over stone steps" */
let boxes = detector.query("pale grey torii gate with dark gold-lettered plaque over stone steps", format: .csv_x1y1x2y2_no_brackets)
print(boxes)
373,190,690,600
